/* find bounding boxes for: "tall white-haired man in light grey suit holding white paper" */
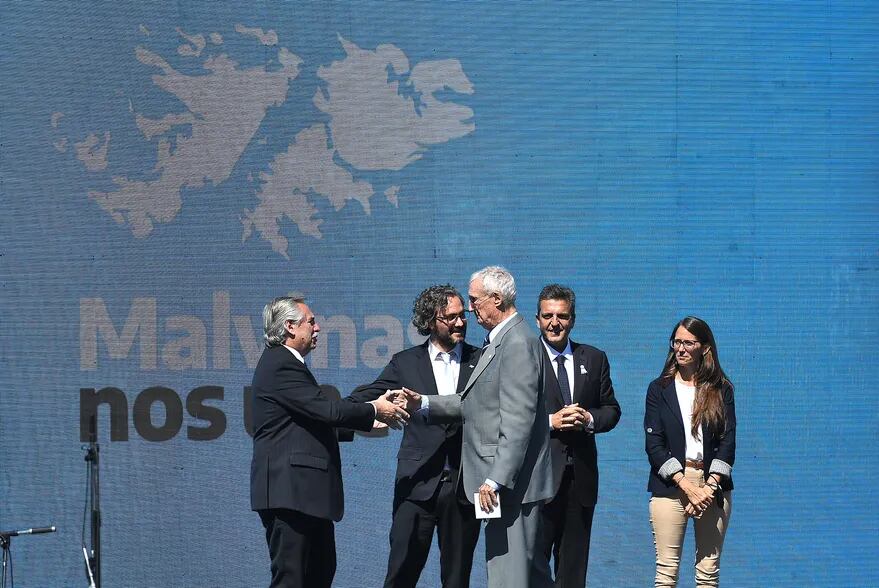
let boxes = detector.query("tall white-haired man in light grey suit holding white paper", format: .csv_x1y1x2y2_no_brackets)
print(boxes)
406,266,555,588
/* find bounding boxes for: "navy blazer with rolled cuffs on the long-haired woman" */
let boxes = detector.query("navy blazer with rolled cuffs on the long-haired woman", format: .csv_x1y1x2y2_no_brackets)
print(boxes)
644,378,736,497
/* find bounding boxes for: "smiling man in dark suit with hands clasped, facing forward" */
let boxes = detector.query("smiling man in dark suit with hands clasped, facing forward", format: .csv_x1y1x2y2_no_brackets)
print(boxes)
537,284,621,588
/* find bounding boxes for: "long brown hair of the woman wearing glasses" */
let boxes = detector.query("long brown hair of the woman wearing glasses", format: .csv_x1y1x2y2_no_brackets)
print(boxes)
659,316,732,439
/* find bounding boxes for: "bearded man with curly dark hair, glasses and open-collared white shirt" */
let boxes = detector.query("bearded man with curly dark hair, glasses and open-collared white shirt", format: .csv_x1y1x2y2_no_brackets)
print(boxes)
351,284,480,588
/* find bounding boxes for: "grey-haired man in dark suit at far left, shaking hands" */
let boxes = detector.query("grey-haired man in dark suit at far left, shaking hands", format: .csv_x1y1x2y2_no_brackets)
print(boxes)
250,297,408,588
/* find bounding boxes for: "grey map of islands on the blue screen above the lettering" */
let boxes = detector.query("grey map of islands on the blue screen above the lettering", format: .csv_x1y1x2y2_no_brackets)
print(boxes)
51,24,476,258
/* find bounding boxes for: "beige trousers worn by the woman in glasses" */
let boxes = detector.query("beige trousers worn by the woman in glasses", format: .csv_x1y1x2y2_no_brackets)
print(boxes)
650,468,732,588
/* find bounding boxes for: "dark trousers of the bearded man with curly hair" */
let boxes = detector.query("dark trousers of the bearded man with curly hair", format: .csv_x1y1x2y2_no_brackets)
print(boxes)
385,480,481,588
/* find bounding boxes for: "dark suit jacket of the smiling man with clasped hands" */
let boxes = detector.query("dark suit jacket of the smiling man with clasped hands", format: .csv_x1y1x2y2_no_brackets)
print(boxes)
543,341,622,506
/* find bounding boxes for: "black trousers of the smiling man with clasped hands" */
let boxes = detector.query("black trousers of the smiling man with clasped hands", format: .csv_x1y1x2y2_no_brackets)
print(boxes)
541,466,595,588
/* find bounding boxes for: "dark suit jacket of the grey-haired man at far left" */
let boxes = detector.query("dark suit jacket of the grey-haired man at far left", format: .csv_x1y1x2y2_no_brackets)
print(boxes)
250,346,375,521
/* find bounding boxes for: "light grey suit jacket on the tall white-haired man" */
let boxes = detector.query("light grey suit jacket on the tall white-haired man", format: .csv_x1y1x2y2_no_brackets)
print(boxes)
428,315,555,503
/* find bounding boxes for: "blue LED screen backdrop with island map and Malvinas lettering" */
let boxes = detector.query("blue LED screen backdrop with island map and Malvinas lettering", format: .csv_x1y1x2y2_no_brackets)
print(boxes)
0,1,879,588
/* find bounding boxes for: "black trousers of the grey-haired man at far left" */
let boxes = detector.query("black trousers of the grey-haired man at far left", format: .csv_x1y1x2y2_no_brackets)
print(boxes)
258,508,336,588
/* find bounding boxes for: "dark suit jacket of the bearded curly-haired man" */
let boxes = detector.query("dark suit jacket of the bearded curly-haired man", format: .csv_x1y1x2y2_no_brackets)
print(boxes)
350,341,479,500
